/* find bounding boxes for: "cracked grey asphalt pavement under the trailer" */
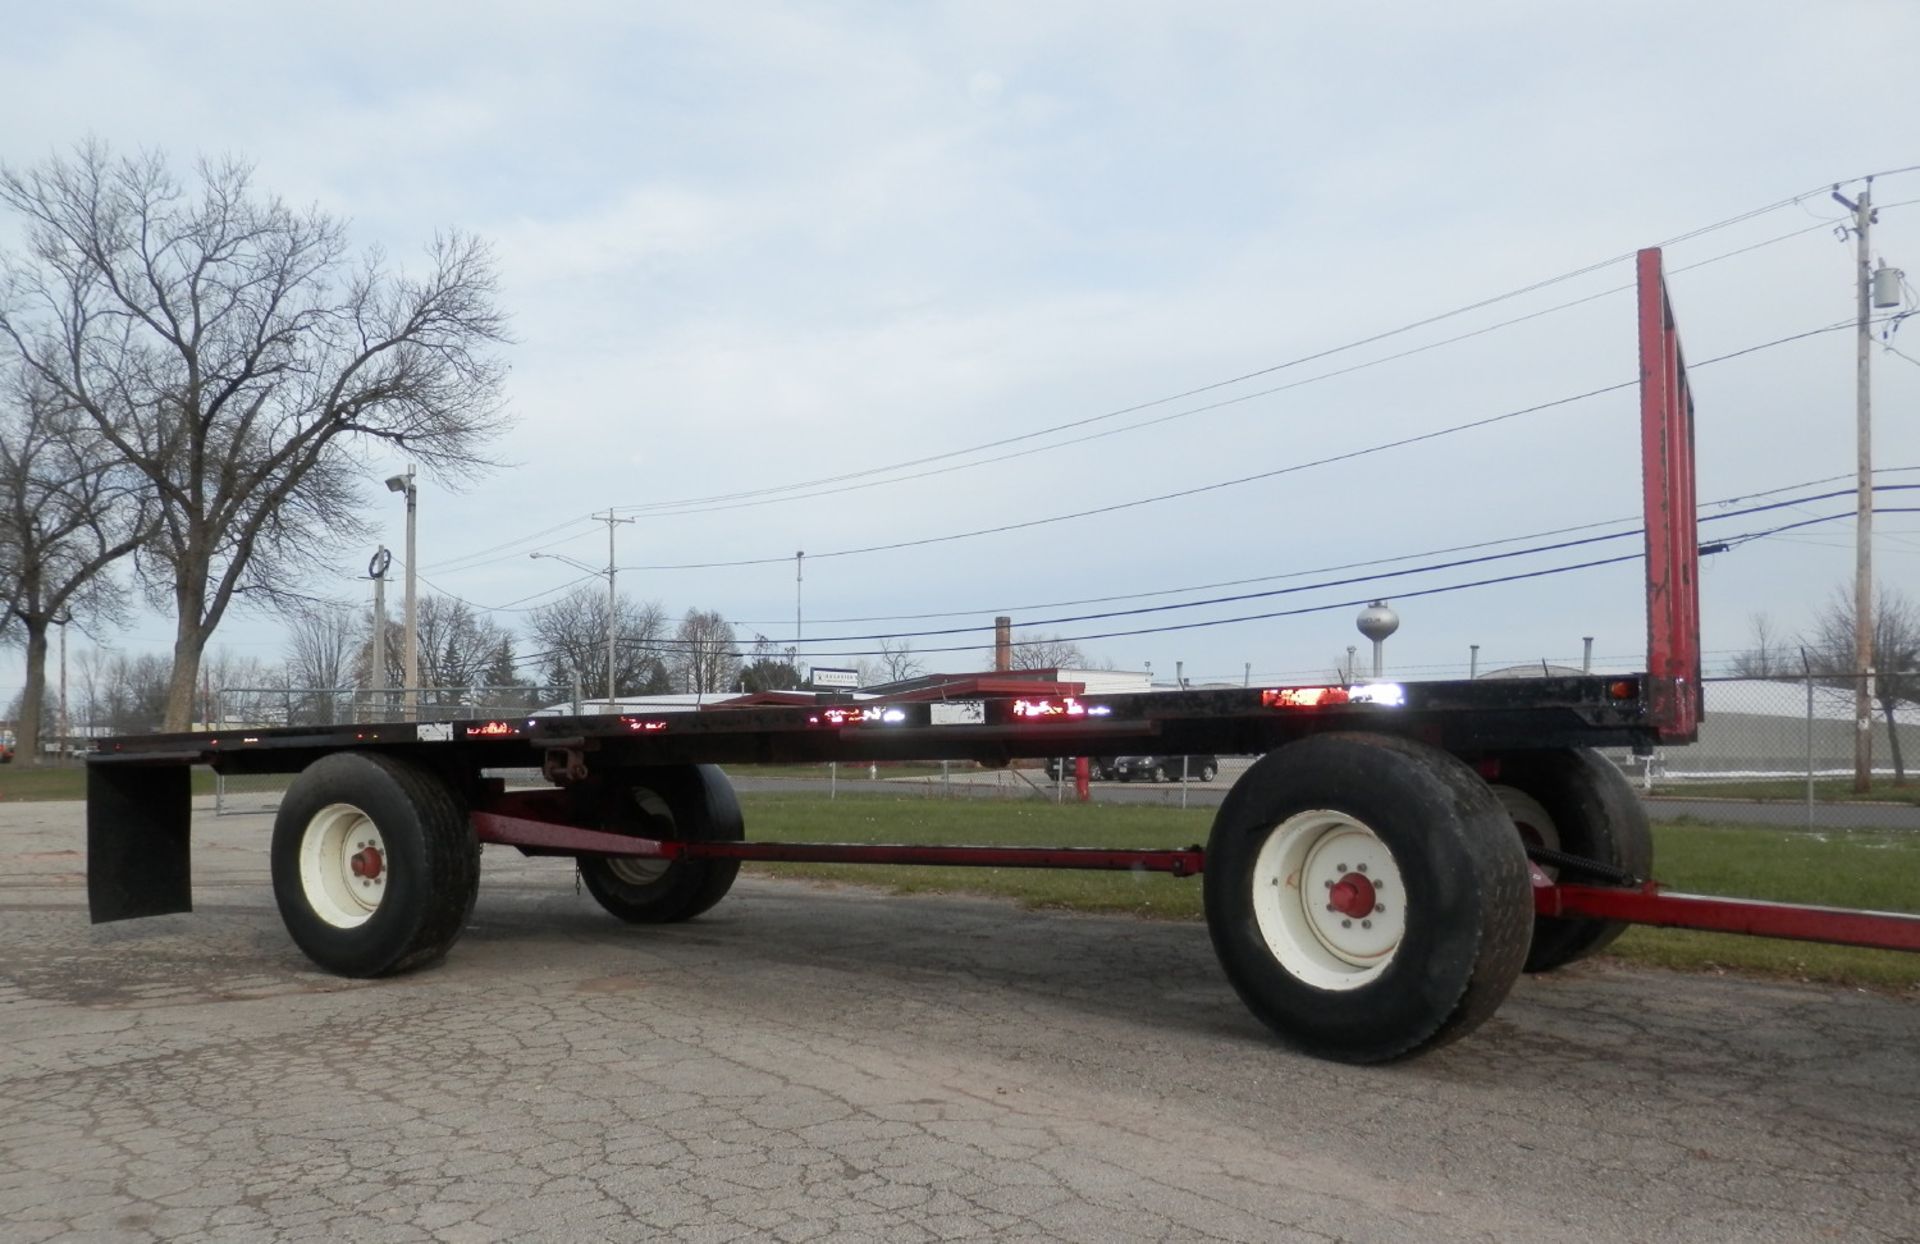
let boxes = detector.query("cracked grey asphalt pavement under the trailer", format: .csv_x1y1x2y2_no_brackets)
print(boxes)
0,804,1920,1244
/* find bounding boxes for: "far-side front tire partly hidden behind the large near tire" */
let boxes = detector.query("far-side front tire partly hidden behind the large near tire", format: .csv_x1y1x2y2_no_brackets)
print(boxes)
1494,747,1653,971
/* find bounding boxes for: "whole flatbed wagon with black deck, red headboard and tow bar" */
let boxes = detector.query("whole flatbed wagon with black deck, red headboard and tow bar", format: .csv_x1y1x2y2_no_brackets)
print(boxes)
86,250,1920,1062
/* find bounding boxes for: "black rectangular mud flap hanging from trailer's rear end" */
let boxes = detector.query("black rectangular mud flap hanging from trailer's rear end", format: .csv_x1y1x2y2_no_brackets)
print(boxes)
86,764,194,923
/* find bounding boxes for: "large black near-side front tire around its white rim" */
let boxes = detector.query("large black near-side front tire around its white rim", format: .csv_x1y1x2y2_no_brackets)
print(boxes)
1206,733,1532,1064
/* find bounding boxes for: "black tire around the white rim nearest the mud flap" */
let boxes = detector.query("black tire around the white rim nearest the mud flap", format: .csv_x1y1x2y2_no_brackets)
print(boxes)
271,751,480,977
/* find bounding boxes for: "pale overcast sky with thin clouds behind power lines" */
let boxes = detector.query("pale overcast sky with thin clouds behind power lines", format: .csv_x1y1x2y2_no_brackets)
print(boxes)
0,0,1920,697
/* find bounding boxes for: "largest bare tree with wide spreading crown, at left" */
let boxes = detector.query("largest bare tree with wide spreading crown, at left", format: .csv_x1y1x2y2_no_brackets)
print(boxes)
0,142,505,728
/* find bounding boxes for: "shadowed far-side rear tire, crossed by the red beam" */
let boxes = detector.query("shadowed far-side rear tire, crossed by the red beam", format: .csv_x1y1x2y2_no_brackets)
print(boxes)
576,764,747,923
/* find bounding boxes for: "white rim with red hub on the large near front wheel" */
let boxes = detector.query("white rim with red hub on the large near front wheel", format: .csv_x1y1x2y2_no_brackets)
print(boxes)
1254,810,1407,991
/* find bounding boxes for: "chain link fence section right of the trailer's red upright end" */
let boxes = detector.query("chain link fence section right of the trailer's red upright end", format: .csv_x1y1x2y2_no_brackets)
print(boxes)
1615,676,1920,829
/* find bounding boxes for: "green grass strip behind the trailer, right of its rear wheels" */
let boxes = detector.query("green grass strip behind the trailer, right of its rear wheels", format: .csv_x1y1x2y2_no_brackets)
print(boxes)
741,795,1920,989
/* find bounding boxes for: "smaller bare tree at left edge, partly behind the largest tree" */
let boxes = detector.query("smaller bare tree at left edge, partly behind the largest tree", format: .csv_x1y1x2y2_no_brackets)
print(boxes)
0,376,150,764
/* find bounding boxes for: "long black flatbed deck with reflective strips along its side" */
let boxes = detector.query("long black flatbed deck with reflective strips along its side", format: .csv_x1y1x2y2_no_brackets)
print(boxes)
88,674,1661,774
